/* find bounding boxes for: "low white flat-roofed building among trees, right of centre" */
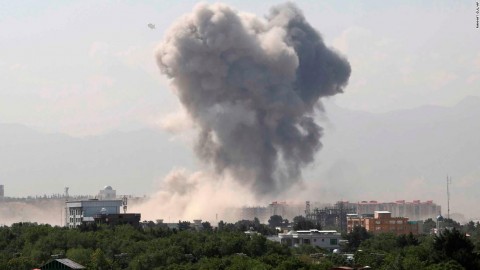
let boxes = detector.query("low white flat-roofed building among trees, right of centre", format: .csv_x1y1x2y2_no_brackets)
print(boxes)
278,229,341,250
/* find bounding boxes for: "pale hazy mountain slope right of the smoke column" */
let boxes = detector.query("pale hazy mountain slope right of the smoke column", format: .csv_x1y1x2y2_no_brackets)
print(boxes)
305,96,480,220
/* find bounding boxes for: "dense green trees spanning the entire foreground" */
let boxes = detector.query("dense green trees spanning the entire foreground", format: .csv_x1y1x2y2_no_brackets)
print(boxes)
0,219,480,270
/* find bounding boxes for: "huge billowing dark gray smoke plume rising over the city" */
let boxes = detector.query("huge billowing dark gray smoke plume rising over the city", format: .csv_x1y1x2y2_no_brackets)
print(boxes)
156,3,351,195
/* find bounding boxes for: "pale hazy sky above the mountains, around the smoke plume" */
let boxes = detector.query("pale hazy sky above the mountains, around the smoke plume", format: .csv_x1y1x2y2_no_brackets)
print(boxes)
0,0,480,136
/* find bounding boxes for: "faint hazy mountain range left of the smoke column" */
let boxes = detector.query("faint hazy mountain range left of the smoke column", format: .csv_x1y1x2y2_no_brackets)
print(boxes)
0,124,195,196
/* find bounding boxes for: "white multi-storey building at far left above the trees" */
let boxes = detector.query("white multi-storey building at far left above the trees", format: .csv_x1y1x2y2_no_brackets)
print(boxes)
65,199,122,228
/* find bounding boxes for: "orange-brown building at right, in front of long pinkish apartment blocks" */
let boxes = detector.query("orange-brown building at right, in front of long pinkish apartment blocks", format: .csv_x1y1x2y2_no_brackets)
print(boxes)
347,211,419,235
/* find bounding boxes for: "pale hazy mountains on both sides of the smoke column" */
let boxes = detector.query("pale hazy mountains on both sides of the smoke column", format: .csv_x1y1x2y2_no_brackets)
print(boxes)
0,97,480,219
